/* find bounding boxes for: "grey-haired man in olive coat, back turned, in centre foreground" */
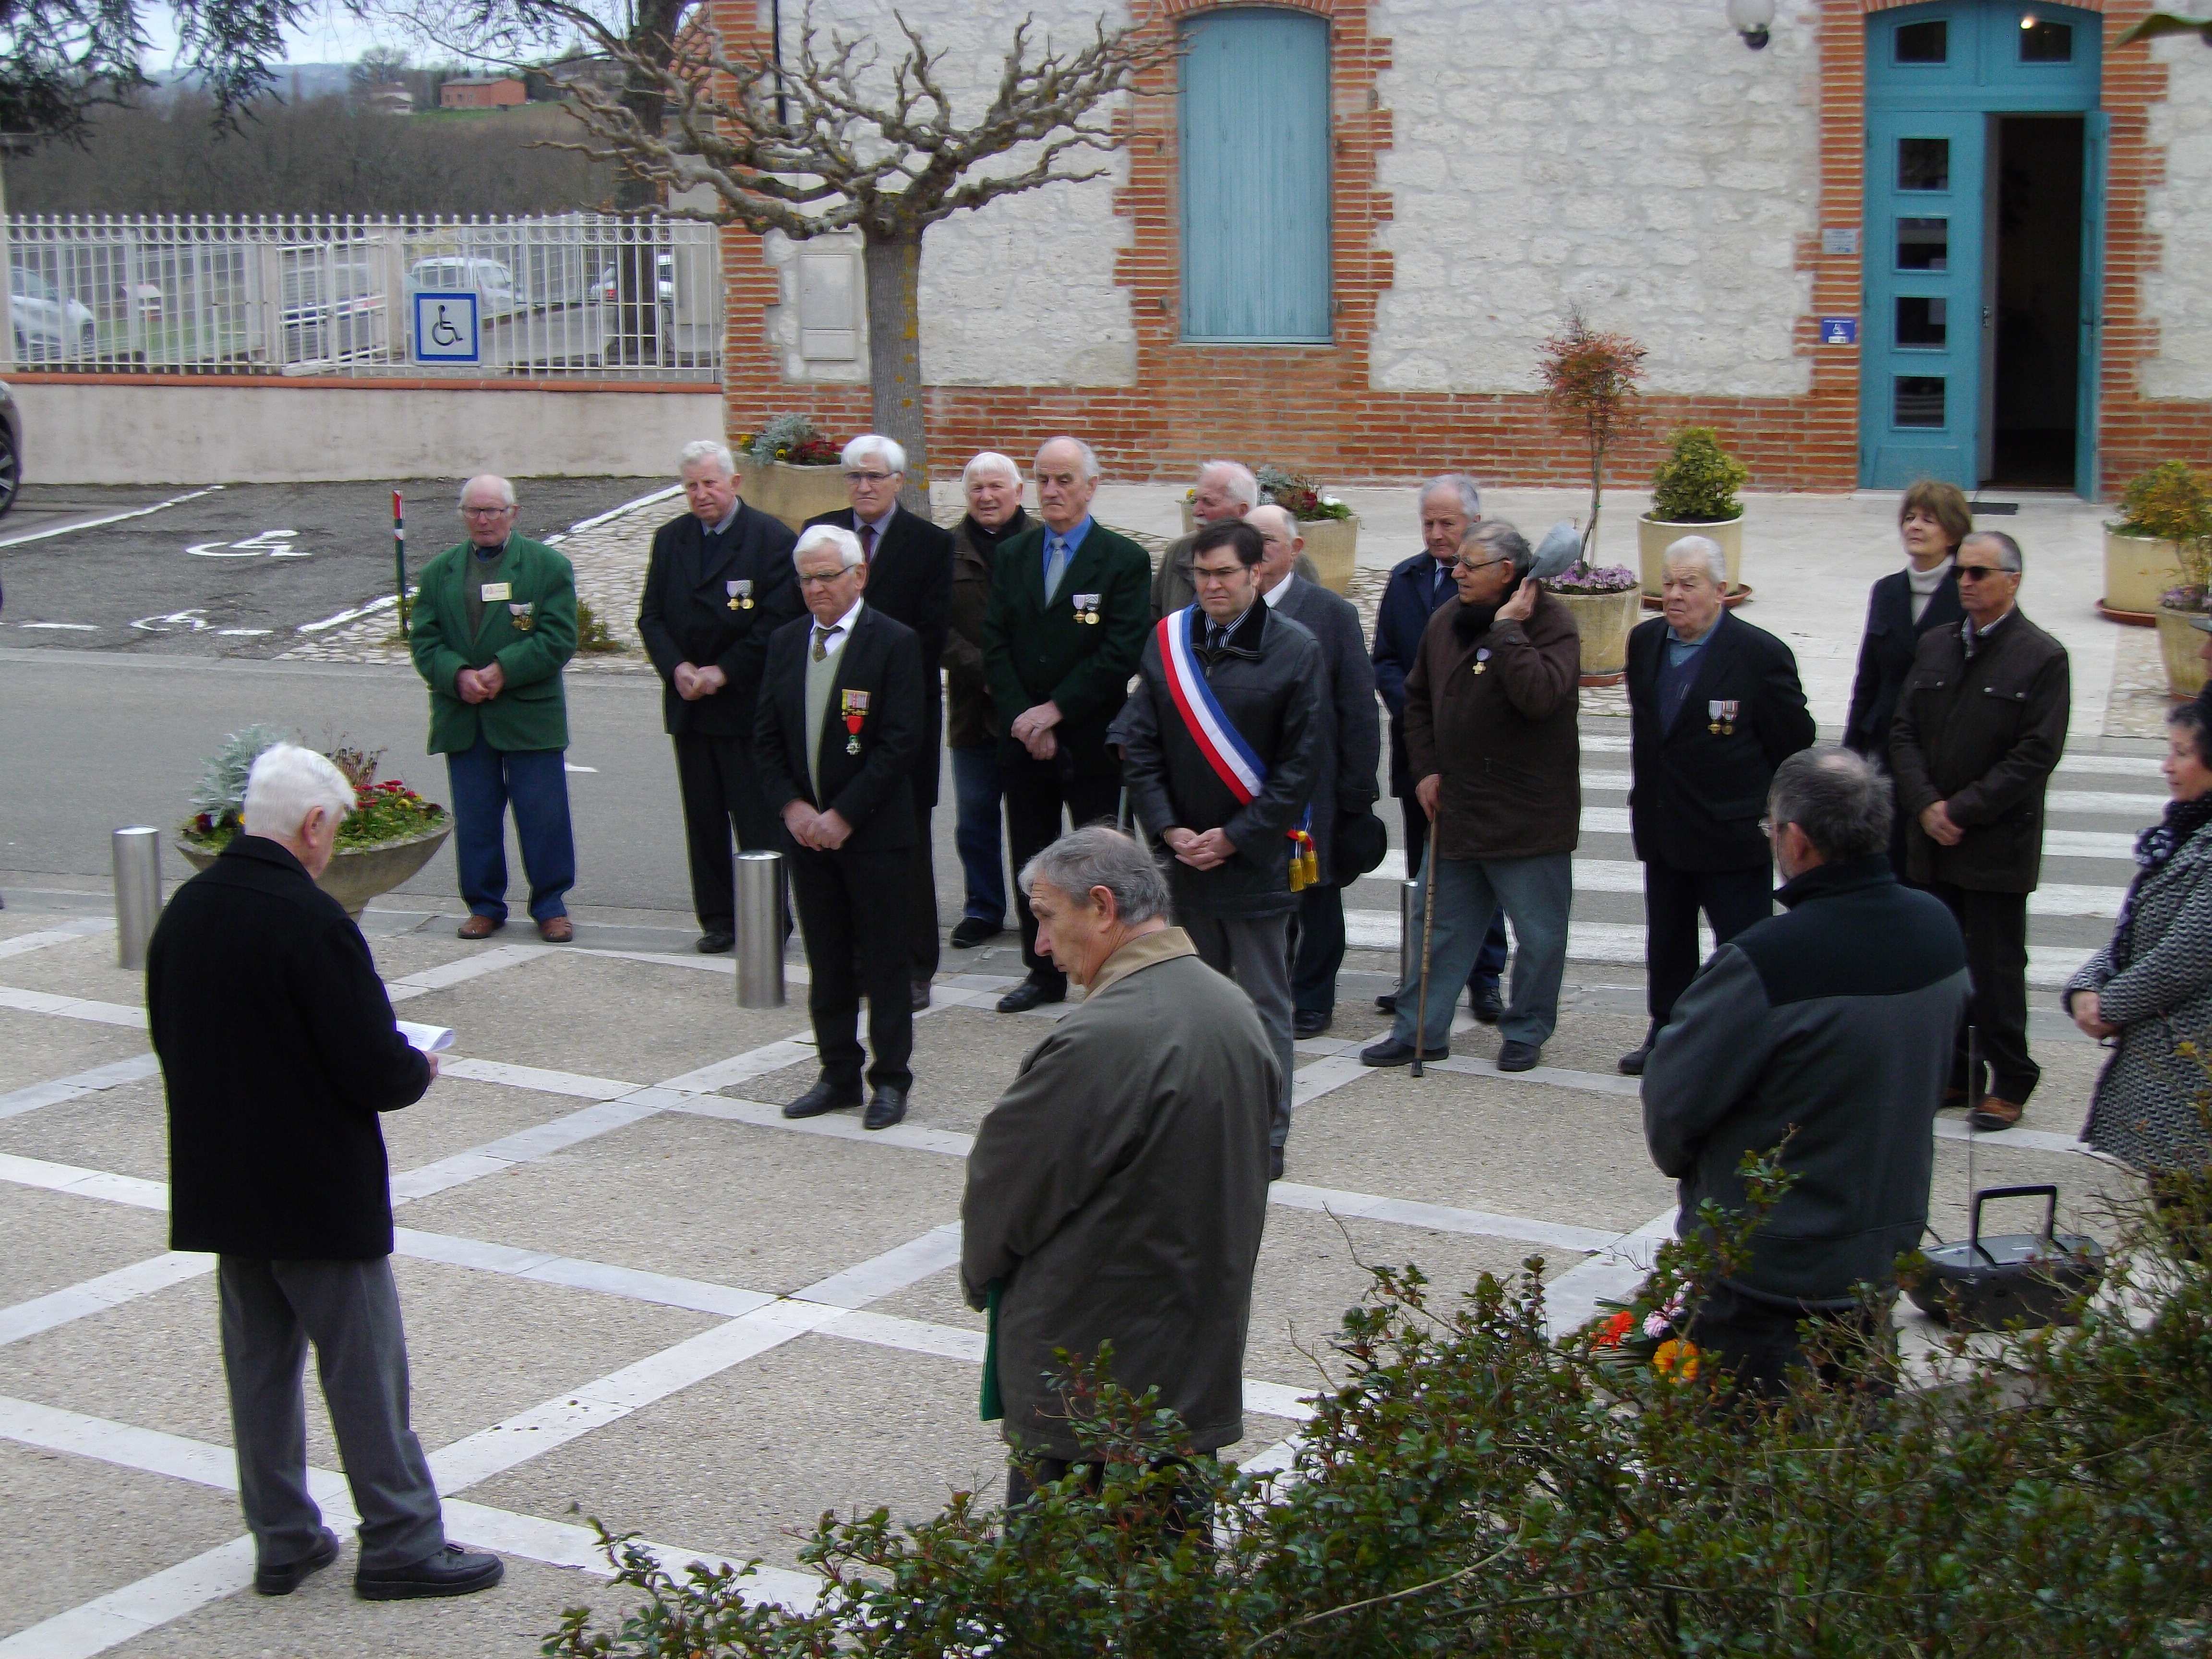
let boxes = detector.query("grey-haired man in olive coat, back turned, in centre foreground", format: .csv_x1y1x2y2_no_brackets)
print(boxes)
960,825,1281,1504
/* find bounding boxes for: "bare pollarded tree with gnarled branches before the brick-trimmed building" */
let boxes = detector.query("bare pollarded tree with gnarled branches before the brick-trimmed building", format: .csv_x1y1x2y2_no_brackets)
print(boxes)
551,0,1172,511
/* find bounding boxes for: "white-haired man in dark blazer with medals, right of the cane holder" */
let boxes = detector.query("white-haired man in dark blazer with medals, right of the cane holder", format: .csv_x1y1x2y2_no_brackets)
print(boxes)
1622,535,1814,1077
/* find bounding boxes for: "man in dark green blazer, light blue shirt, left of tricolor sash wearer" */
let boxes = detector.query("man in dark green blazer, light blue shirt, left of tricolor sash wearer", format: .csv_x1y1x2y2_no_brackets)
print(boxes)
982,438,1153,1013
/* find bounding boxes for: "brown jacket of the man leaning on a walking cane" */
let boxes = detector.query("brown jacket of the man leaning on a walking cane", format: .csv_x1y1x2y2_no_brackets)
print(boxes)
1405,593,1582,858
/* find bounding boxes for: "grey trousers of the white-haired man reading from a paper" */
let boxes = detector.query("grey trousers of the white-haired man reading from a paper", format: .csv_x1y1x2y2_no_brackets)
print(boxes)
217,1256,445,1568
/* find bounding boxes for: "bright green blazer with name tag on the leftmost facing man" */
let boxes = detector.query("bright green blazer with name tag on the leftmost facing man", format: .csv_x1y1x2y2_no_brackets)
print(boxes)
407,535,575,754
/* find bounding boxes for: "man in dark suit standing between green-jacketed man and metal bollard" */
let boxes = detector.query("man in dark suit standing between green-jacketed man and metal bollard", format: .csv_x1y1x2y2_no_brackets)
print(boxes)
637,438,801,956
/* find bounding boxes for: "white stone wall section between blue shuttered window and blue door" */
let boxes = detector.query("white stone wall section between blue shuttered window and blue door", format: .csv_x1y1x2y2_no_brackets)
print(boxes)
1371,0,1820,396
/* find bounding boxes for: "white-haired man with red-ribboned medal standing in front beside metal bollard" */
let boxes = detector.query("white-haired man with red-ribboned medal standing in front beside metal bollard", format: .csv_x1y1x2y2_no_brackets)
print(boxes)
752,524,925,1128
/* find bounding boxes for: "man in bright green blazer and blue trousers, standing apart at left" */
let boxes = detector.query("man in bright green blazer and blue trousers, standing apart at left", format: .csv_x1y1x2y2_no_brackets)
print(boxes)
407,473,575,945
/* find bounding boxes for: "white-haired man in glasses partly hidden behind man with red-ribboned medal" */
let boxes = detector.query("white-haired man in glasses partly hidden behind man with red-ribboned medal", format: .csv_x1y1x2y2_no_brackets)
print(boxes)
807,432,953,1009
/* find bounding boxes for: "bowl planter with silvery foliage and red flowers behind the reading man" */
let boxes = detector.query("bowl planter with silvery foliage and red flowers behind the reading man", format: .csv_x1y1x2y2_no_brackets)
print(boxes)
175,725,454,923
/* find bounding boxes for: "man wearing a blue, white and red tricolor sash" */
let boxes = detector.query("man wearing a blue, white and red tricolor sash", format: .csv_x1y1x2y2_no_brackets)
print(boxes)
1113,522,1327,1179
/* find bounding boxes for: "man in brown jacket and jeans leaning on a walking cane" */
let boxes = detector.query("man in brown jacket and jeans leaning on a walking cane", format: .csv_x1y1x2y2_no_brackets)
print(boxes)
1360,520,1582,1070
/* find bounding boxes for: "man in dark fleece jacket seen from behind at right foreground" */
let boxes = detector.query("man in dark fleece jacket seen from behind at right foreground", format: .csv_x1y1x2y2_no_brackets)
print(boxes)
1644,750,1967,1394
